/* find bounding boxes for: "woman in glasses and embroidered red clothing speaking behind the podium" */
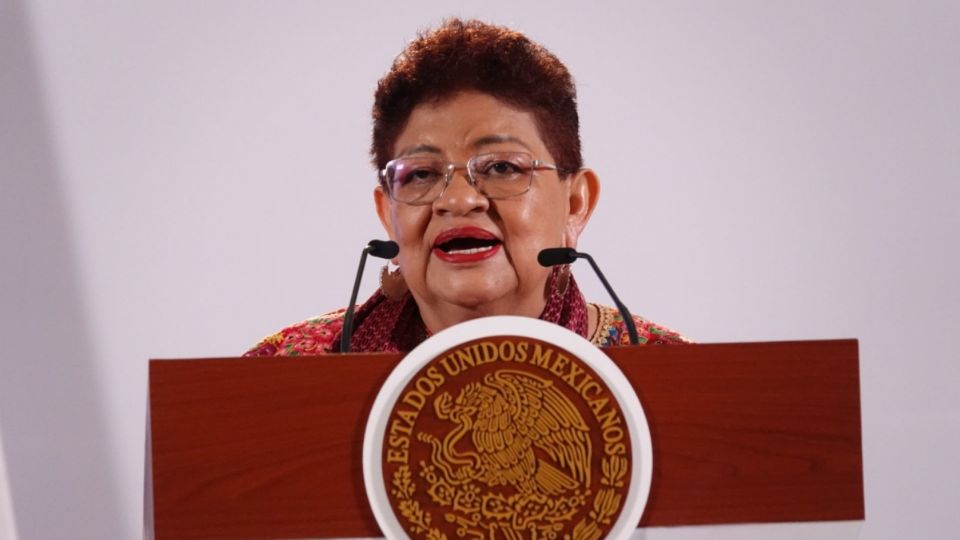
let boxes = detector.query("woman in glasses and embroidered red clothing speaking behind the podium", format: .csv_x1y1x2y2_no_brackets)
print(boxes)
247,19,684,356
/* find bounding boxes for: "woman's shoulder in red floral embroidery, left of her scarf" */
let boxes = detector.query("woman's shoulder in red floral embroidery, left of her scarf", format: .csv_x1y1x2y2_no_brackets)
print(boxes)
244,309,346,356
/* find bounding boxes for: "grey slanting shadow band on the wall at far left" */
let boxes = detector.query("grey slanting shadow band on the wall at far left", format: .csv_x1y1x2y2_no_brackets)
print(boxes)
0,0,124,540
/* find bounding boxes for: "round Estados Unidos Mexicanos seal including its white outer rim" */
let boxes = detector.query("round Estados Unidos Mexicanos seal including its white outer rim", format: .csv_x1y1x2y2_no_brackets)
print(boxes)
363,317,652,540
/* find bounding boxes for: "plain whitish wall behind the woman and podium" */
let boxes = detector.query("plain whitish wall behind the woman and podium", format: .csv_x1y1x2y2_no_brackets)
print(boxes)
0,0,960,539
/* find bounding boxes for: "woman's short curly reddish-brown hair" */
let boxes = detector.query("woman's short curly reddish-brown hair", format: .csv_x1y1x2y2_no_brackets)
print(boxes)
370,19,583,174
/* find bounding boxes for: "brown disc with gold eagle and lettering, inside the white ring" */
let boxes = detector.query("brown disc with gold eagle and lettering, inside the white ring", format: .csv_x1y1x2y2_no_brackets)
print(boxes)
381,337,639,540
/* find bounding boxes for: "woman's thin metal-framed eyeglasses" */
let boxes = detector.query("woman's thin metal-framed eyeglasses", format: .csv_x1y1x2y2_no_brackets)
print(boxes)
380,152,562,205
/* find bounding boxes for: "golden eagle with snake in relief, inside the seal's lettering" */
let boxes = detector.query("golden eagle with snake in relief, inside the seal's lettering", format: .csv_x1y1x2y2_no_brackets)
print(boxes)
398,369,591,539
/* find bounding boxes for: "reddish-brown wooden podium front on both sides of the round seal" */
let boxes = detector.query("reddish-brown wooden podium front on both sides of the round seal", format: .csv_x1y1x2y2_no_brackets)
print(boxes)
145,340,864,539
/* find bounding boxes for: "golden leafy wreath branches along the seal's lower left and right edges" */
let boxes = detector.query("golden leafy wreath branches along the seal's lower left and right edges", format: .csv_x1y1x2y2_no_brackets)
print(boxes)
391,456,628,540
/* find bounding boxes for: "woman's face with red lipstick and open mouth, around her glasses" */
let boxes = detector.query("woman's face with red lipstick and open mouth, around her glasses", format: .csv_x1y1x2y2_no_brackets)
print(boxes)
375,92,599,332
